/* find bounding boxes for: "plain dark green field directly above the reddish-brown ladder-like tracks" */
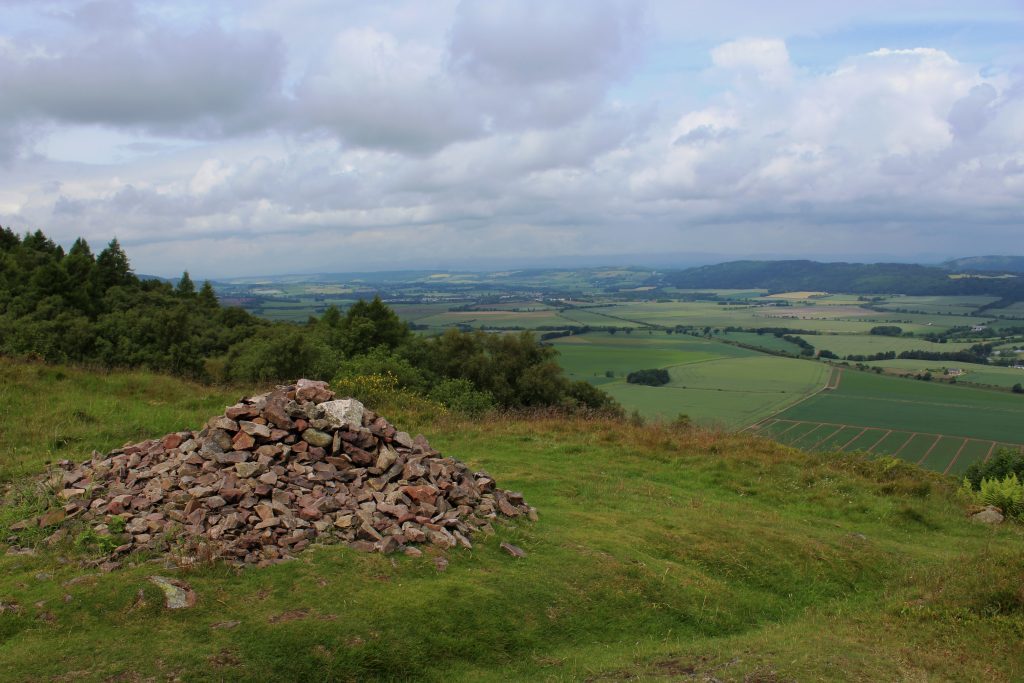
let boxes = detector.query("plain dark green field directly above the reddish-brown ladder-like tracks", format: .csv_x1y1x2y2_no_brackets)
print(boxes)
775,371,1024,443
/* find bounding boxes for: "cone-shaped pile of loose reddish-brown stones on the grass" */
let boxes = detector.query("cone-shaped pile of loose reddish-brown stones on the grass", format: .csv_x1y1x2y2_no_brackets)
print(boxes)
48,380,537,564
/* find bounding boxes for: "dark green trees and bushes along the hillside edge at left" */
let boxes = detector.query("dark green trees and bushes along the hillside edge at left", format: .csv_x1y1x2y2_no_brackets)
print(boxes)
0,228,621,412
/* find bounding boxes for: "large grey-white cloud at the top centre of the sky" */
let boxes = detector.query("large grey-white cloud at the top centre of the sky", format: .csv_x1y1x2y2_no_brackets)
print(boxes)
294,0,639,155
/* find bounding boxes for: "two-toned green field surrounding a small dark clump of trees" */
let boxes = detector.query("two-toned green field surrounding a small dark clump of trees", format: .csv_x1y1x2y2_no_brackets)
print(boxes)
554,333,829,429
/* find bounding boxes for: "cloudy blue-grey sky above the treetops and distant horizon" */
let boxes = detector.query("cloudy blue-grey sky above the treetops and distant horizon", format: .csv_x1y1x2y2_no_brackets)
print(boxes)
0,0,1024,279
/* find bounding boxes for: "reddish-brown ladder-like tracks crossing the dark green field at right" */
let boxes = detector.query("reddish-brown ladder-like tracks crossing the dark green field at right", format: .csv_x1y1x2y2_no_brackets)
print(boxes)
743,417,1024,474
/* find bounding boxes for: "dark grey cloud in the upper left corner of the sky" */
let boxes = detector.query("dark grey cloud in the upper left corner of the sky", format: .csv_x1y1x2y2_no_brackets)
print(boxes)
0,2,284,138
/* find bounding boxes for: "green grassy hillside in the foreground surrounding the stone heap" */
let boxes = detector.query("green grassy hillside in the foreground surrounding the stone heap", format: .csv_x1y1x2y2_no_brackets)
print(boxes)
0,360,1024,681
